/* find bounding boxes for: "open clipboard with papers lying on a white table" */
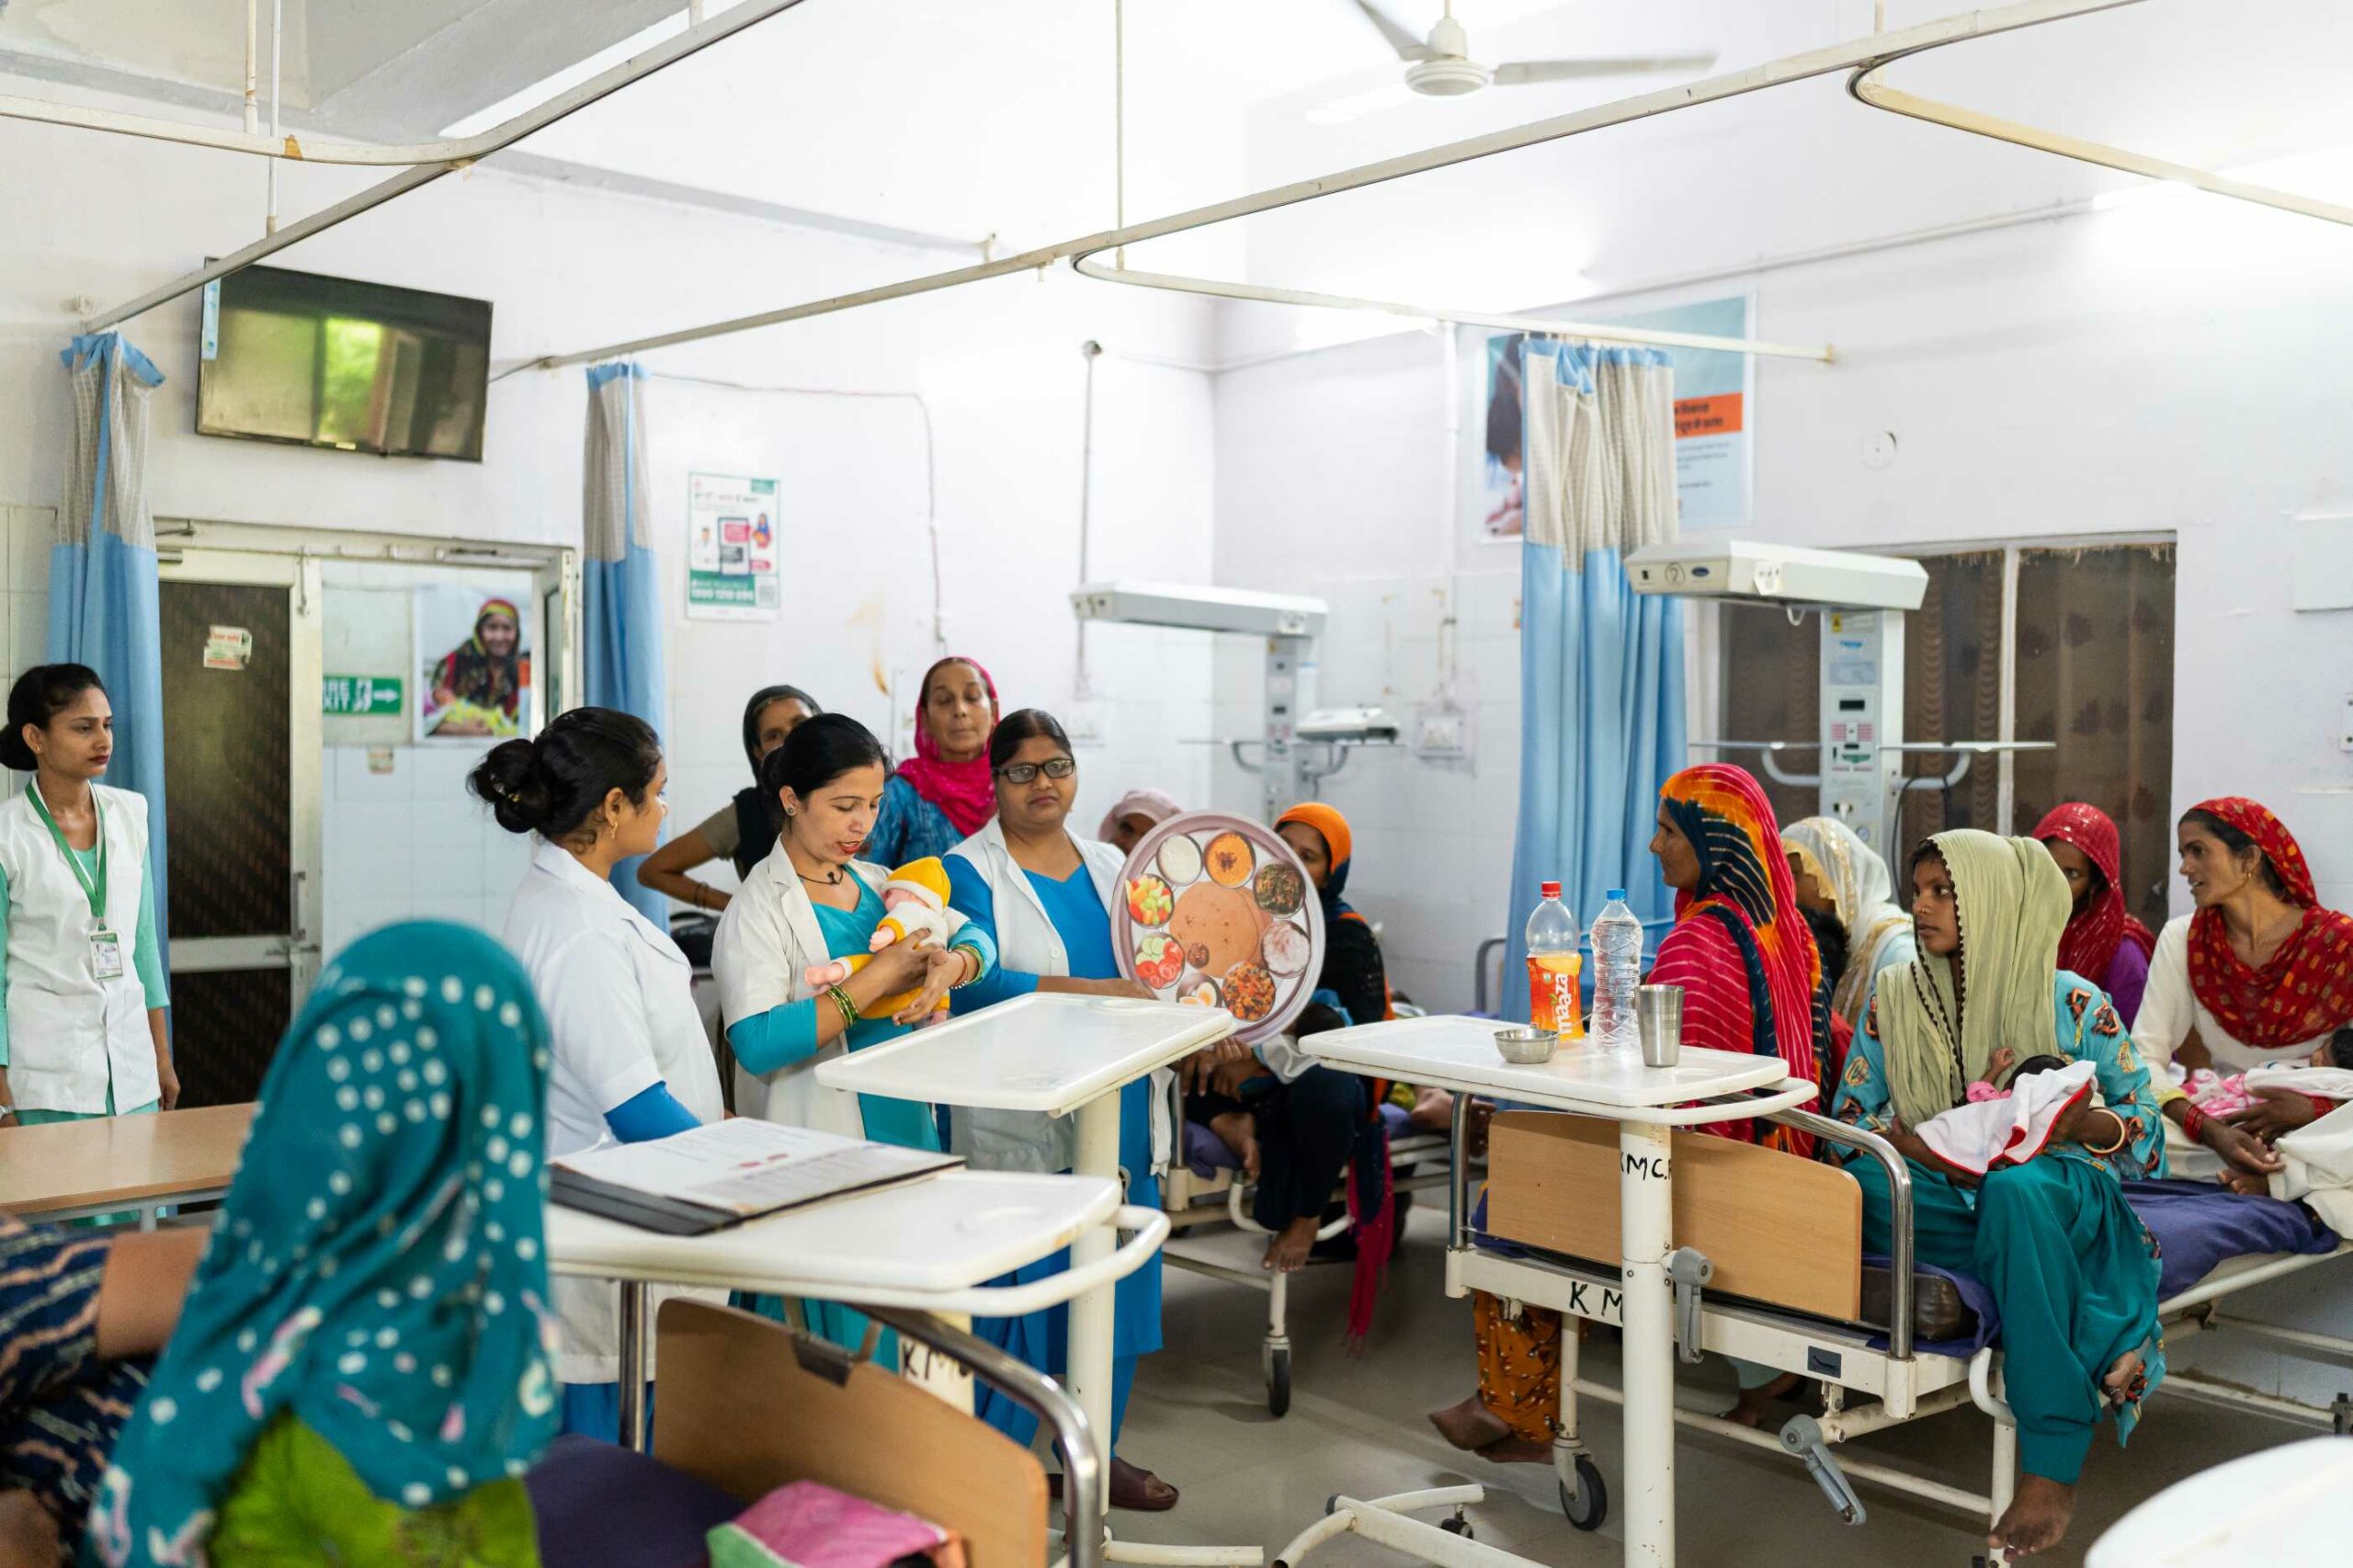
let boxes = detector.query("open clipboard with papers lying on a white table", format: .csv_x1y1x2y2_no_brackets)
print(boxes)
548,1119,965,1236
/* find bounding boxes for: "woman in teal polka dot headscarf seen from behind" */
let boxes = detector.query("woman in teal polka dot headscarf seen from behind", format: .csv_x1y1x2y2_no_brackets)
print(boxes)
85,923,558,1568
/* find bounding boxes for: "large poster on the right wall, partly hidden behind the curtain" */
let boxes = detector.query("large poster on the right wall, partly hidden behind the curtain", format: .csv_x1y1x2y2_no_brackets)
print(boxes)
1471,294,1756,540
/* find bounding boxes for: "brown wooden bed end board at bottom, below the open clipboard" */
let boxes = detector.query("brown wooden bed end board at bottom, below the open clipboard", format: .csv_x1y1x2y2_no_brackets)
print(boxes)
654,1300,1047,1568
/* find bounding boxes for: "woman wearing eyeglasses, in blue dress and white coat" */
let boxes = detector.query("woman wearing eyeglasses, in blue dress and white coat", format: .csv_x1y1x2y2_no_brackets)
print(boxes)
949,709,1176,1512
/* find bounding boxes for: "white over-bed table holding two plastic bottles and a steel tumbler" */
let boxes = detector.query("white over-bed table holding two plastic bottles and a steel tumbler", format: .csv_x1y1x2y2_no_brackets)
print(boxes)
1278,1017,1814,1568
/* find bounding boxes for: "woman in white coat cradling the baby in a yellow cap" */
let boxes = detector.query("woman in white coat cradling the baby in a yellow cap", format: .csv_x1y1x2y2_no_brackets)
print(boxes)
710,713,997,1361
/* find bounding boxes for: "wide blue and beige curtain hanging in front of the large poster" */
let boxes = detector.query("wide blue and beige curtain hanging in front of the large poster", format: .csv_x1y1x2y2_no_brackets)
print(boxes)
1504,339,1685,1019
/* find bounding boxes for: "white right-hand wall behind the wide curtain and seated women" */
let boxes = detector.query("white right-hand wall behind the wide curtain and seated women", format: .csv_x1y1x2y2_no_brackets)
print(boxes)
1217,146,2353,1403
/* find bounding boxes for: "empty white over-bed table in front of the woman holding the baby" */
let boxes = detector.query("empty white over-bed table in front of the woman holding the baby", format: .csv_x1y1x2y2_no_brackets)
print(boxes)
816,994,1261,1563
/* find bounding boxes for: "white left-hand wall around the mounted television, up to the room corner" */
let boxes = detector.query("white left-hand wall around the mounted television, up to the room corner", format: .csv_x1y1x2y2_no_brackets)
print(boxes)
0,103,1214,923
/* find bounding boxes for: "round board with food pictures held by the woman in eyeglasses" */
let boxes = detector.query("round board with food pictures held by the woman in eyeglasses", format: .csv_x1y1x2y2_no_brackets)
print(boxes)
1110,812,1324,1043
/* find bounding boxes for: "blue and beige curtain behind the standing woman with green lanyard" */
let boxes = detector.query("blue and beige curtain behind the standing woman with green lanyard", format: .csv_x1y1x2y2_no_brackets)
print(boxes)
47,332,169,959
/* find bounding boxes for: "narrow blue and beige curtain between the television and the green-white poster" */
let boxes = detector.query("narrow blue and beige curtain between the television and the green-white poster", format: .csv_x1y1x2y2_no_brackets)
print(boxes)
581,362,671,930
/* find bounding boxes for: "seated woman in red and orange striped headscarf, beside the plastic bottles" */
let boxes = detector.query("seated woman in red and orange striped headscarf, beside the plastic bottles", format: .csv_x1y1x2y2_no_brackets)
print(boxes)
1430,763,1831,1464
